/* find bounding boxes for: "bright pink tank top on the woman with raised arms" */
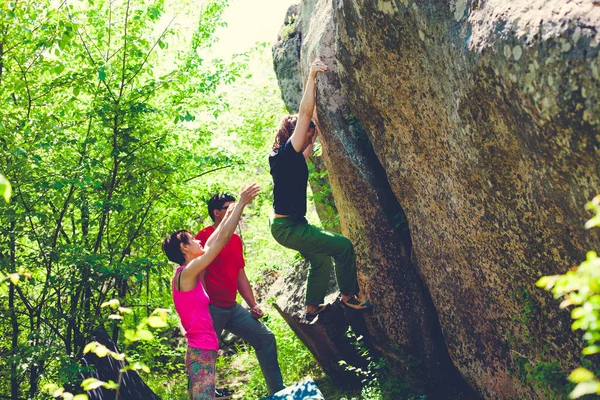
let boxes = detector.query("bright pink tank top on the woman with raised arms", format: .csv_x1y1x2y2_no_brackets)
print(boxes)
171,265,219,351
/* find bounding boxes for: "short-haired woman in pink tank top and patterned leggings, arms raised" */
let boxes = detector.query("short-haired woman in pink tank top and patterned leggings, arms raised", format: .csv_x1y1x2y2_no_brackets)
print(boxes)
162,184,260,400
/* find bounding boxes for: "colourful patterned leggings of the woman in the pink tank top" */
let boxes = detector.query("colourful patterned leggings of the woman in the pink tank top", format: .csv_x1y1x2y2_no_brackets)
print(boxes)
185,346,217,400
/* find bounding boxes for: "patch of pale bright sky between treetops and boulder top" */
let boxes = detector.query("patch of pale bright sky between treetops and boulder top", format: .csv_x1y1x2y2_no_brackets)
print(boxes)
211,0,300,58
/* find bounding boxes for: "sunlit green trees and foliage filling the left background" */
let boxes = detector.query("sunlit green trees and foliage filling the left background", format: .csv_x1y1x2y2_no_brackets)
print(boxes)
0,0,300,399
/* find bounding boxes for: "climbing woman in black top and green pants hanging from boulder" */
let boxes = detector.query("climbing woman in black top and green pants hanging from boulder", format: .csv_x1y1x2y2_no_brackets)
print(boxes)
269,58,371,321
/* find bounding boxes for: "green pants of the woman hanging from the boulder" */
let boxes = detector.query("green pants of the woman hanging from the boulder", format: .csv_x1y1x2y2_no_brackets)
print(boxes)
271,218,358,305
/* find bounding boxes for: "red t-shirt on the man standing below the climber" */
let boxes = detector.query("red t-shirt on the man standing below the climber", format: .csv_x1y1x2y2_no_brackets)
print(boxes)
196,226,245,308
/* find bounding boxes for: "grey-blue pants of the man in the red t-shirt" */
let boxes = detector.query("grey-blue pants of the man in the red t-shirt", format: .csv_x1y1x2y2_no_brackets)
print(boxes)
209,304,285,394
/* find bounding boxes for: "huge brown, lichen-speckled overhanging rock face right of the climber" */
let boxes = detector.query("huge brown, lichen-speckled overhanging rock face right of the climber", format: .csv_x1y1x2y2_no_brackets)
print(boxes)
274,0,600,399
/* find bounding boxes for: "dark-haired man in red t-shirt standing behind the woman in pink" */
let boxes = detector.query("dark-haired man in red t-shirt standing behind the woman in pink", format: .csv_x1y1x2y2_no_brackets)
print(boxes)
196,193,285,394
